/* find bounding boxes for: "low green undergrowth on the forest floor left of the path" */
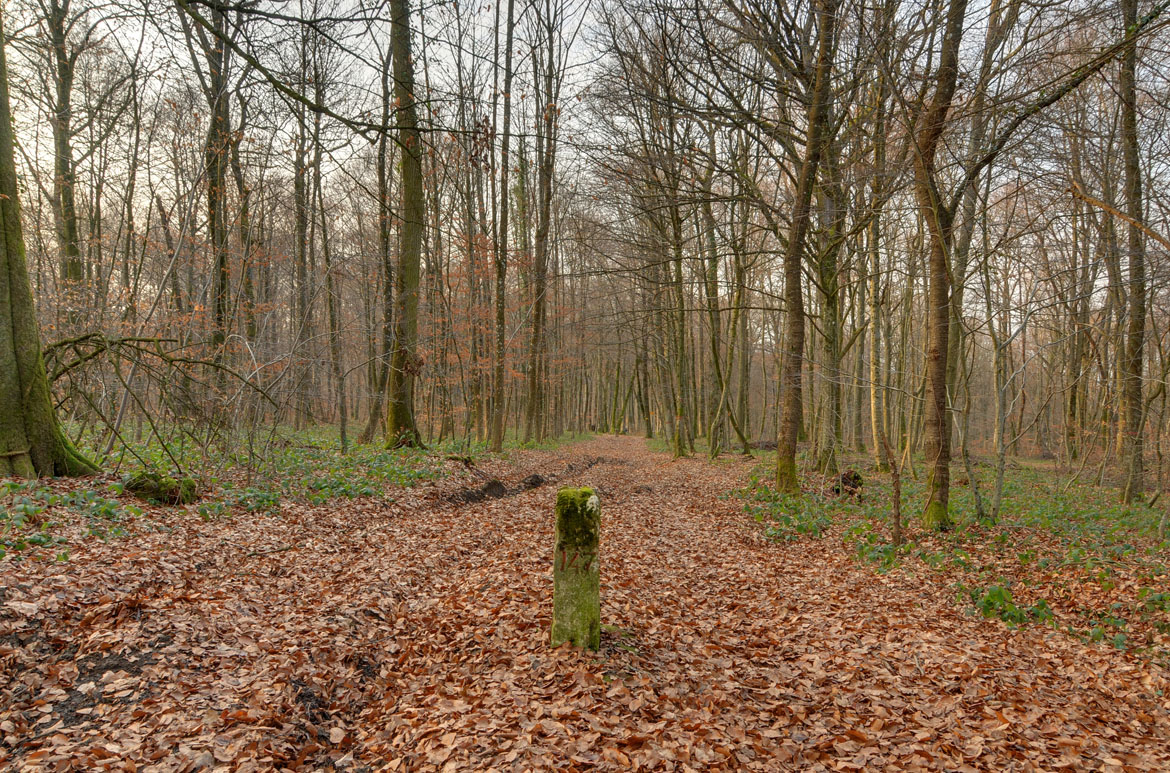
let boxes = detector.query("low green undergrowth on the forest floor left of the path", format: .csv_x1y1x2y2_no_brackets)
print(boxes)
0,427,587,560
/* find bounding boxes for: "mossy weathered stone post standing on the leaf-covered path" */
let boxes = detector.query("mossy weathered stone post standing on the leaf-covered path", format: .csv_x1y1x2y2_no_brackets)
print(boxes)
551,489,601,650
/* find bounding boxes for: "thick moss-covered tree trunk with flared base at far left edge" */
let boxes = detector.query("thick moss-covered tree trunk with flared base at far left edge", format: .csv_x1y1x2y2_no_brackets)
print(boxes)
0,19,96,477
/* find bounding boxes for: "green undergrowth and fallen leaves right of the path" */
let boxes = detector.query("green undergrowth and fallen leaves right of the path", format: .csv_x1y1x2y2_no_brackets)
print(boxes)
731,454,1170,662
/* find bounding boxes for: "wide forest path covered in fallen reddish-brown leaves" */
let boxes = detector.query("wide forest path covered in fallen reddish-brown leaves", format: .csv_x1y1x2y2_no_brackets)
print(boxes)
0,437,1170,771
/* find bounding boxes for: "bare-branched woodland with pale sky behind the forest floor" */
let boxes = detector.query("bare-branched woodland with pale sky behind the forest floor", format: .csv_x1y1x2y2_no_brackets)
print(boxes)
6,0,1170,520
